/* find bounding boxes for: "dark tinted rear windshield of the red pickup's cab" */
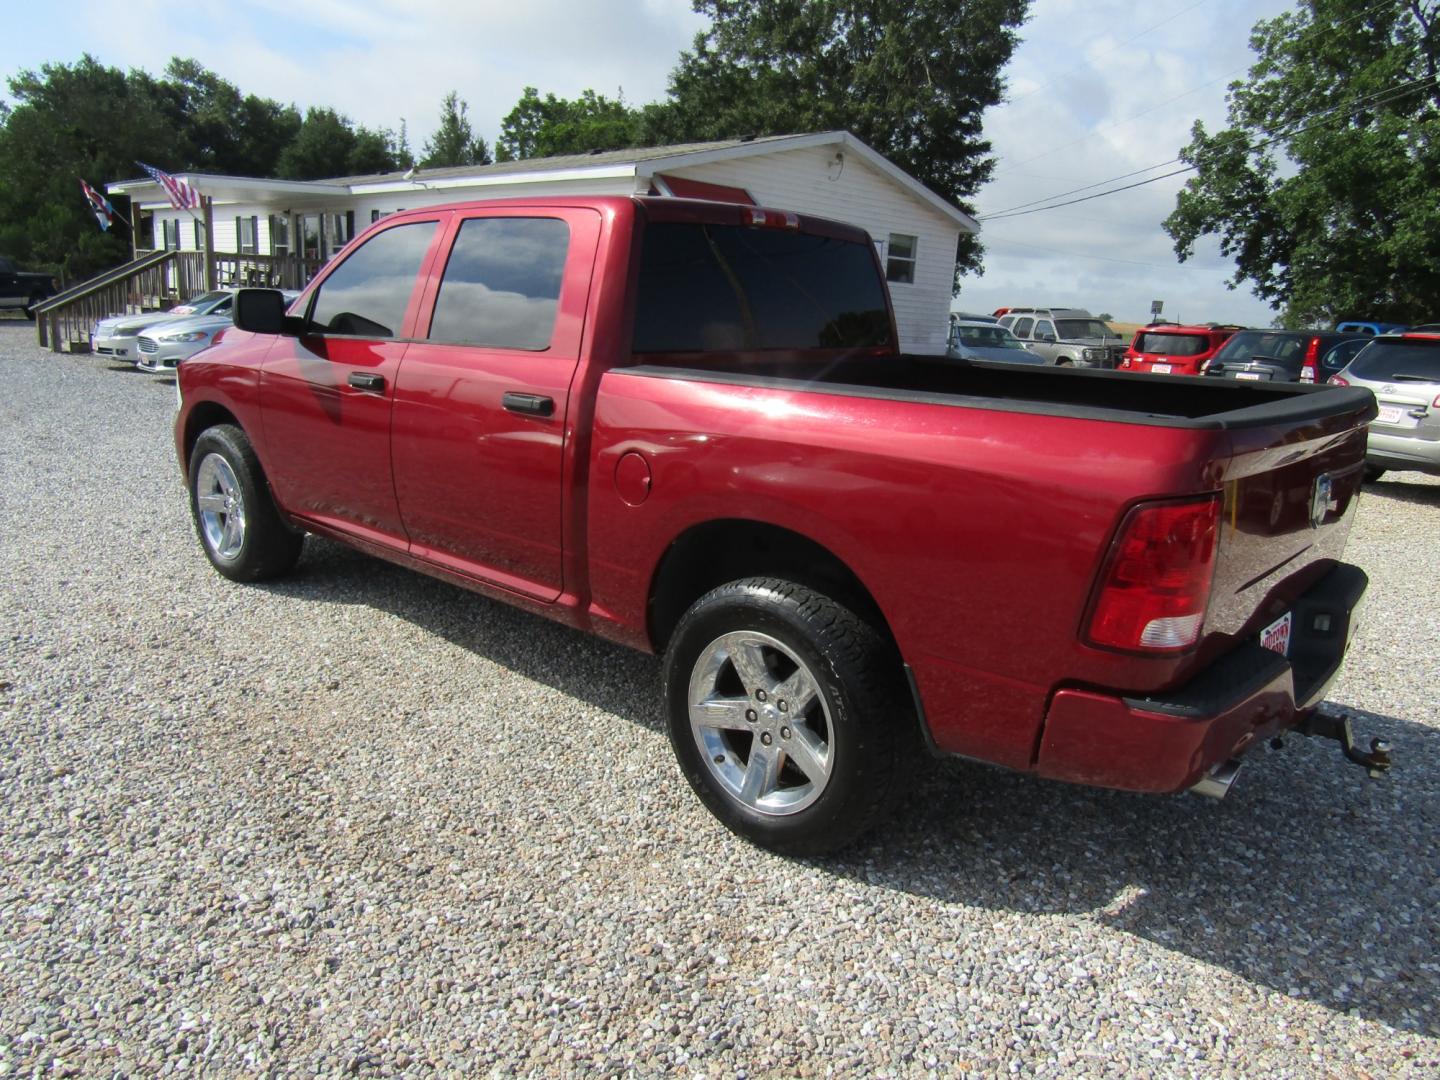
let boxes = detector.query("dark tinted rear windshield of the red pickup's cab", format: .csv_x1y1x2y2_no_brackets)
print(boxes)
635,222,890,353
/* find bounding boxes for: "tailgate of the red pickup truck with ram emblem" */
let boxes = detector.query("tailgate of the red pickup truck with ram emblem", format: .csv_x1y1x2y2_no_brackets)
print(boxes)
1202,395,1375,652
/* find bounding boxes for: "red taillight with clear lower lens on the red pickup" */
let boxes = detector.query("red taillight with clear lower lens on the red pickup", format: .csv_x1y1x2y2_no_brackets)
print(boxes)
1086,495,1220,652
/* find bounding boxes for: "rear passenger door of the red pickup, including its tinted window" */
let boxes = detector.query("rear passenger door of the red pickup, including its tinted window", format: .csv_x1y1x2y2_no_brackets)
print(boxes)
393,206,600,600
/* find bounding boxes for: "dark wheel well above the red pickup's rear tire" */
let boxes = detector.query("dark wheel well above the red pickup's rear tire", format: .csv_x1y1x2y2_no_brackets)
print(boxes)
648,520,893,652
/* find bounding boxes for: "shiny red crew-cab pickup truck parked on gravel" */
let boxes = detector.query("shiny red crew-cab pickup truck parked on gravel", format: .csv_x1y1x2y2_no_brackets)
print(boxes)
174,197,1382,852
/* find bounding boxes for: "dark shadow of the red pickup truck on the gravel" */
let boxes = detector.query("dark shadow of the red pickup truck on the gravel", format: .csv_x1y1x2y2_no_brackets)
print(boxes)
265,540,1440,1035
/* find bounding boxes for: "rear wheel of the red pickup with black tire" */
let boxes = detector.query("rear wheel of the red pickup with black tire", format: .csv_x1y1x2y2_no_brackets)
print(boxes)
665,577,914,855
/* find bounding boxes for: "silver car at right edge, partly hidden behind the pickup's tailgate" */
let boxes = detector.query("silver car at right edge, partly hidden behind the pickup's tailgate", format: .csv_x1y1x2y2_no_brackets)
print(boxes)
1331,334,1440,480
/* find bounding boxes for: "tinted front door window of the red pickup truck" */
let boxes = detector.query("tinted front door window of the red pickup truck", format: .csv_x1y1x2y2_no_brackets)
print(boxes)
310,222,436,337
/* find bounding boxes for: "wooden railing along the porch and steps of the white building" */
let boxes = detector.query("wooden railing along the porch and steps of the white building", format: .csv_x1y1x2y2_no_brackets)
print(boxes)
35,251,324,353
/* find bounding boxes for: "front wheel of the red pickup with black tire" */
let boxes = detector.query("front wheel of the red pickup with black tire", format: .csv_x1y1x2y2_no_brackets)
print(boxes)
189,423,305,582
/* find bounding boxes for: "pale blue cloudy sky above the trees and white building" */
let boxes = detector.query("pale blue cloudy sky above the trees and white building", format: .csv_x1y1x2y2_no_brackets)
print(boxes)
0,0,1293,325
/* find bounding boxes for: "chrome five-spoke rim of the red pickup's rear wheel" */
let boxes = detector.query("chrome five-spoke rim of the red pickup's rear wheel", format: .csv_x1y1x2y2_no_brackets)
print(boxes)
688,631,834,816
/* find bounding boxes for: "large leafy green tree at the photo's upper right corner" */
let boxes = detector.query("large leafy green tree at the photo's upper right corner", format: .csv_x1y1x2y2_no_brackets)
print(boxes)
1165,0,1440,325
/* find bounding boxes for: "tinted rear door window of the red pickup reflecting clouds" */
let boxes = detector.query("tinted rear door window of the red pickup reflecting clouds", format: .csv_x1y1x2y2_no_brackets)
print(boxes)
429,217,570,350
